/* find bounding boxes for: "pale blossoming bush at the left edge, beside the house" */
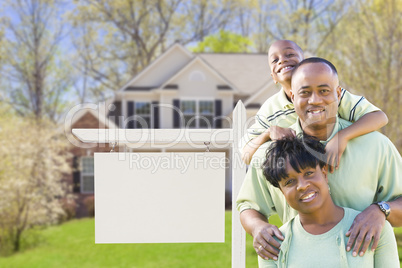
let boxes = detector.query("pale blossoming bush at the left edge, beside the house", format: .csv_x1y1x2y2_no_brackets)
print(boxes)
0,106,71,255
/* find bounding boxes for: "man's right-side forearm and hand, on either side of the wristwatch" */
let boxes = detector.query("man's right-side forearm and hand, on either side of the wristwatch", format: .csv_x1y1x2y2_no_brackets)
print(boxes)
346,196,402,256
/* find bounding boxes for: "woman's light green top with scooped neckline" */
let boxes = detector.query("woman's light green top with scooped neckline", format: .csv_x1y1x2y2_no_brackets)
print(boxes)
258,208,399,268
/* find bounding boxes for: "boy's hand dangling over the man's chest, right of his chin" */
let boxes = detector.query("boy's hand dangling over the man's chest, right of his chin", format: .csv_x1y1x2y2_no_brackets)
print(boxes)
325,132,348,173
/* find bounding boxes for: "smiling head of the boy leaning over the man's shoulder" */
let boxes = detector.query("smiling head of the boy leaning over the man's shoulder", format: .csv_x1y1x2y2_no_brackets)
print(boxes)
268,40,303,83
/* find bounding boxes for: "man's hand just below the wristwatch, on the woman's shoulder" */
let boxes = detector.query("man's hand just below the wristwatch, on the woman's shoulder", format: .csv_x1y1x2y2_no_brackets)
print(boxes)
346,204,385,257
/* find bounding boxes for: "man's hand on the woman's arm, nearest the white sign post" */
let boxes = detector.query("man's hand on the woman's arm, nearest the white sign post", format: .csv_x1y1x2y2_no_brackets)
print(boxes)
252,223,284,260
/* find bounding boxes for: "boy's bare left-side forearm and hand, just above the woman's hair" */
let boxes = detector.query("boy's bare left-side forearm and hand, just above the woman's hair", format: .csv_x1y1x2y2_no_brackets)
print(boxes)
241,126,296,165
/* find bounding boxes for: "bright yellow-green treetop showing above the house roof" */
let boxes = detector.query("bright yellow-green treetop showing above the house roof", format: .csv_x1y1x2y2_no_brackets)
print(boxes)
192,30,253,52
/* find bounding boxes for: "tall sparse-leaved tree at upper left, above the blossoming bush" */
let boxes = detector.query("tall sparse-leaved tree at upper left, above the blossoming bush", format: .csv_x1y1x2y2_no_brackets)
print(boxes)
2,0,73,121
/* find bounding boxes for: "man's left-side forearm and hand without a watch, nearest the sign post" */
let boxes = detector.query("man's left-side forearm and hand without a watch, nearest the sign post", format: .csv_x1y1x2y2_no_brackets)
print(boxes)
240,209,284,260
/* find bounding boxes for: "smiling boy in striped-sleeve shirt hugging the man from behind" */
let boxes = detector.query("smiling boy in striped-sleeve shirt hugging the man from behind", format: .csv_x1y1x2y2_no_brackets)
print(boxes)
242,40,388,172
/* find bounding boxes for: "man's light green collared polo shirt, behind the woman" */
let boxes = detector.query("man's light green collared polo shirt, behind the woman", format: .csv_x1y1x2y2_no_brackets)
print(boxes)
237,118,402,223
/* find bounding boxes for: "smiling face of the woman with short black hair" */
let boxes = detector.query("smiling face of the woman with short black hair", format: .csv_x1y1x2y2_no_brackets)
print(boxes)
279,161,330,214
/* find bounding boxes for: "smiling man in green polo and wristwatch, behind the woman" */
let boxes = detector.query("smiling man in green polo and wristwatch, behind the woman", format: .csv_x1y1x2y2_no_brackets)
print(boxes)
237,58,402,260
